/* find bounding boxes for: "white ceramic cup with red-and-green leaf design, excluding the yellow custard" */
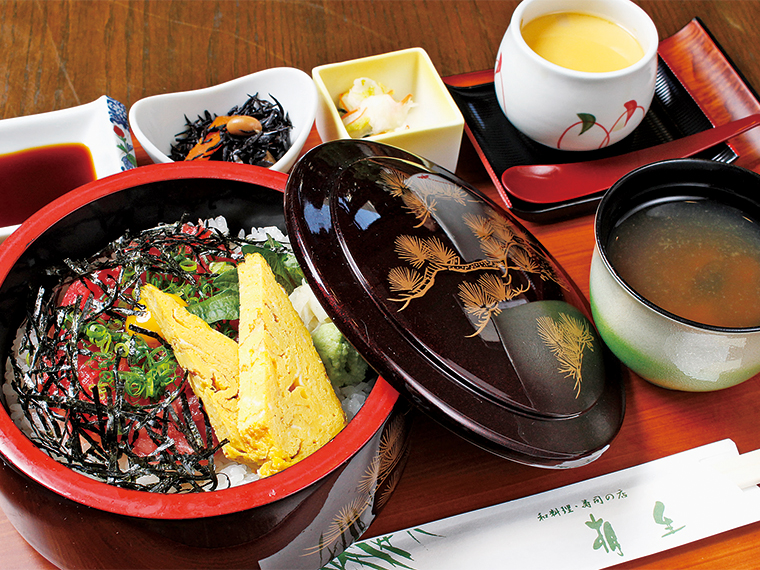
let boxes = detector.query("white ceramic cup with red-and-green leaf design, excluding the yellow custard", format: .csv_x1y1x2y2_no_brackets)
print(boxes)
494,0,659,151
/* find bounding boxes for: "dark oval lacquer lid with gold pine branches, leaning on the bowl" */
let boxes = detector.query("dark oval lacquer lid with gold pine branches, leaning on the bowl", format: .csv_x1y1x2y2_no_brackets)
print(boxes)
285,140,625,467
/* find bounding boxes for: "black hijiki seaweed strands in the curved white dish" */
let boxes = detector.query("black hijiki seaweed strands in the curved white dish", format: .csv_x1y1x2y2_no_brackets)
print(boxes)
169,94,293,166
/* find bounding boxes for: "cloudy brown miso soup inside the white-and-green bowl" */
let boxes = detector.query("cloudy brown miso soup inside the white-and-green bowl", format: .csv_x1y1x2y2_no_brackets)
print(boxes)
607,200,760,327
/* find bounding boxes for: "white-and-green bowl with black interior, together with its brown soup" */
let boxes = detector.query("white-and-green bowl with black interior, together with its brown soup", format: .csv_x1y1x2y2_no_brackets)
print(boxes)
590,159,760,392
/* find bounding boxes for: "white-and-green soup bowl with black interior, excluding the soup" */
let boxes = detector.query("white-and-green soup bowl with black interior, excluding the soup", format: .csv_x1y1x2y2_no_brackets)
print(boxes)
590,159,760,392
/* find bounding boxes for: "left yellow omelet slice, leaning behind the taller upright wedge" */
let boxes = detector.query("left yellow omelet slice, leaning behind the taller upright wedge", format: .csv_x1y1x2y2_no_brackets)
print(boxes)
140,284,252,466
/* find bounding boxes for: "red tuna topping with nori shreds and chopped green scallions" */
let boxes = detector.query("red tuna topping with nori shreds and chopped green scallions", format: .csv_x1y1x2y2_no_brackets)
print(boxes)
5,217,296,492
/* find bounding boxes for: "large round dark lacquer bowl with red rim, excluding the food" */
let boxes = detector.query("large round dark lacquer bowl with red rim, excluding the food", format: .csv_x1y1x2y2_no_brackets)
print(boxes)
0,163,409,570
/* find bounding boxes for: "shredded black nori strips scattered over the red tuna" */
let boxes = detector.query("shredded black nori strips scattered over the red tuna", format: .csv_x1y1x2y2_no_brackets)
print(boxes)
5,217,284,492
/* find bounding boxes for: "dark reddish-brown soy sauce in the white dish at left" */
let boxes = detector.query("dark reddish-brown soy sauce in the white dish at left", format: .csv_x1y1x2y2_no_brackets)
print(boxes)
0,143,96,227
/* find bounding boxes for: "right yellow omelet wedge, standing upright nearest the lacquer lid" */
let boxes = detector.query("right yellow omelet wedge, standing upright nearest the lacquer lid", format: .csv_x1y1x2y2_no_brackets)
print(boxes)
237,254,346,476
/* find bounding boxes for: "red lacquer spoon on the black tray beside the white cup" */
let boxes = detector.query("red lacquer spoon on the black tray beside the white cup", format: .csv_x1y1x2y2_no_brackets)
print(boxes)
501,113,760,204
